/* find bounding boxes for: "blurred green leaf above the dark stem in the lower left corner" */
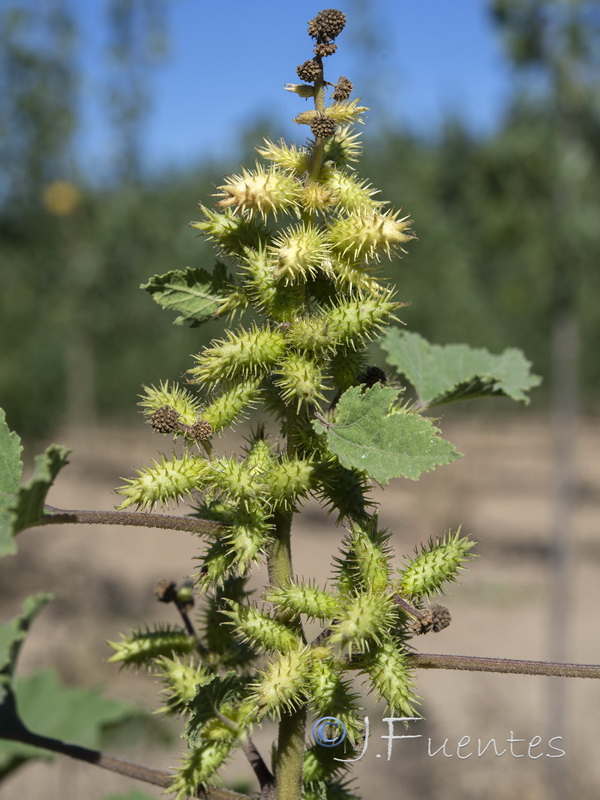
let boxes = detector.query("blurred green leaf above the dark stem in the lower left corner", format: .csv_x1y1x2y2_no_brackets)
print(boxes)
0,670,147,777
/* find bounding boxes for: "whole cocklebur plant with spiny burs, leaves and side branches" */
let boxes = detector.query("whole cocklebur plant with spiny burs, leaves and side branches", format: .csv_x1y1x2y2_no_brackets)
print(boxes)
0,9,599,800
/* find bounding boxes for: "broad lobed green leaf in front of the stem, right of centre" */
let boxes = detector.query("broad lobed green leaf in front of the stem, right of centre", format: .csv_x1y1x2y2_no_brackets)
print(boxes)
313,384,461,484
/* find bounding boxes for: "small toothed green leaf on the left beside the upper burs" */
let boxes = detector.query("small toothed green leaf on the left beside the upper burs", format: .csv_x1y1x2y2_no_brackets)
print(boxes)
141,262,245,328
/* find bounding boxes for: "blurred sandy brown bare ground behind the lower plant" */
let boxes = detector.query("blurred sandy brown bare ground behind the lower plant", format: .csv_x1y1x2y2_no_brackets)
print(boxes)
0,409,600,800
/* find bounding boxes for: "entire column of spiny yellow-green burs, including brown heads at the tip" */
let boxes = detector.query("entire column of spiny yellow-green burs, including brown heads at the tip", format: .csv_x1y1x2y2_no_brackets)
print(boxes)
113,10,472,798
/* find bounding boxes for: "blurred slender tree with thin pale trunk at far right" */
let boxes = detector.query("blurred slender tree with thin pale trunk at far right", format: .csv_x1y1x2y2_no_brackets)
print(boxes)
493,0,600,798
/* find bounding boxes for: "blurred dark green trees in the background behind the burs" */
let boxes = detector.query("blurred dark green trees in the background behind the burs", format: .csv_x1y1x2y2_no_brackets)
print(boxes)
0,0,600,438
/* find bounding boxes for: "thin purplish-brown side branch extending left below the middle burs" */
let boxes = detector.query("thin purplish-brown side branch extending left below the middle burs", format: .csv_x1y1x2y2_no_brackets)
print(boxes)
39,505,225,536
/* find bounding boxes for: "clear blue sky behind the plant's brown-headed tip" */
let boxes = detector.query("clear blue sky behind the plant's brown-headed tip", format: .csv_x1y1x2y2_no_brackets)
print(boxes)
75,0,511,175
